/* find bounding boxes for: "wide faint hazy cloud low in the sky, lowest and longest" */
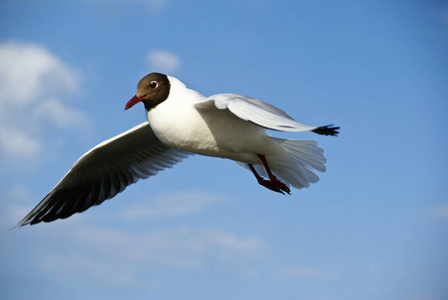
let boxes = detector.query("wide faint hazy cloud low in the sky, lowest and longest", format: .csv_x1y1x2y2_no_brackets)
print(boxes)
34,225,266,289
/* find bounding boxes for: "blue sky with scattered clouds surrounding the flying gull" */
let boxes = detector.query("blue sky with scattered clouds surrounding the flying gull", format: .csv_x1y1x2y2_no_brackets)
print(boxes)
0,0,448,300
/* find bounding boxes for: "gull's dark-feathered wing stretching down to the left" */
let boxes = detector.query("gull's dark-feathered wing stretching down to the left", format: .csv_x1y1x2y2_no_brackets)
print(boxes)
16,122,190,227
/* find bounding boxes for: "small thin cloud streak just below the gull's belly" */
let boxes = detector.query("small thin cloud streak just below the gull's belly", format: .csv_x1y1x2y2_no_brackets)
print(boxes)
121,192,220,219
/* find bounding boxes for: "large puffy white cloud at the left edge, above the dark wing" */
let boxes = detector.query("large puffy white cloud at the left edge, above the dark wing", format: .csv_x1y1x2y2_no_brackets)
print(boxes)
0,41,91,165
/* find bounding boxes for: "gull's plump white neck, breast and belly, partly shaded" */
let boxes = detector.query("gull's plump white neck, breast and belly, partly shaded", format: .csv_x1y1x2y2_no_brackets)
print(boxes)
146,77,287,164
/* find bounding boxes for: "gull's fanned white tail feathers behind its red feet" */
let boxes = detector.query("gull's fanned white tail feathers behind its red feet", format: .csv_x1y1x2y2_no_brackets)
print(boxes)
239,137,327,189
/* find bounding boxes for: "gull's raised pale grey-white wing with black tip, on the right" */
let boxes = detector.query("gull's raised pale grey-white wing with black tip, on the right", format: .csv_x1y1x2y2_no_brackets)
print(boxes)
196,94,339,135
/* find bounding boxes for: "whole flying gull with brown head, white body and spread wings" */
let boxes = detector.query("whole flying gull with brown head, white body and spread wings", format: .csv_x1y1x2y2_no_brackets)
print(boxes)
16,73,339,227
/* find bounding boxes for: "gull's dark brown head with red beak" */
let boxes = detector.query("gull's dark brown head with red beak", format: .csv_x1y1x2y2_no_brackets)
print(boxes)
124,73,170,110
